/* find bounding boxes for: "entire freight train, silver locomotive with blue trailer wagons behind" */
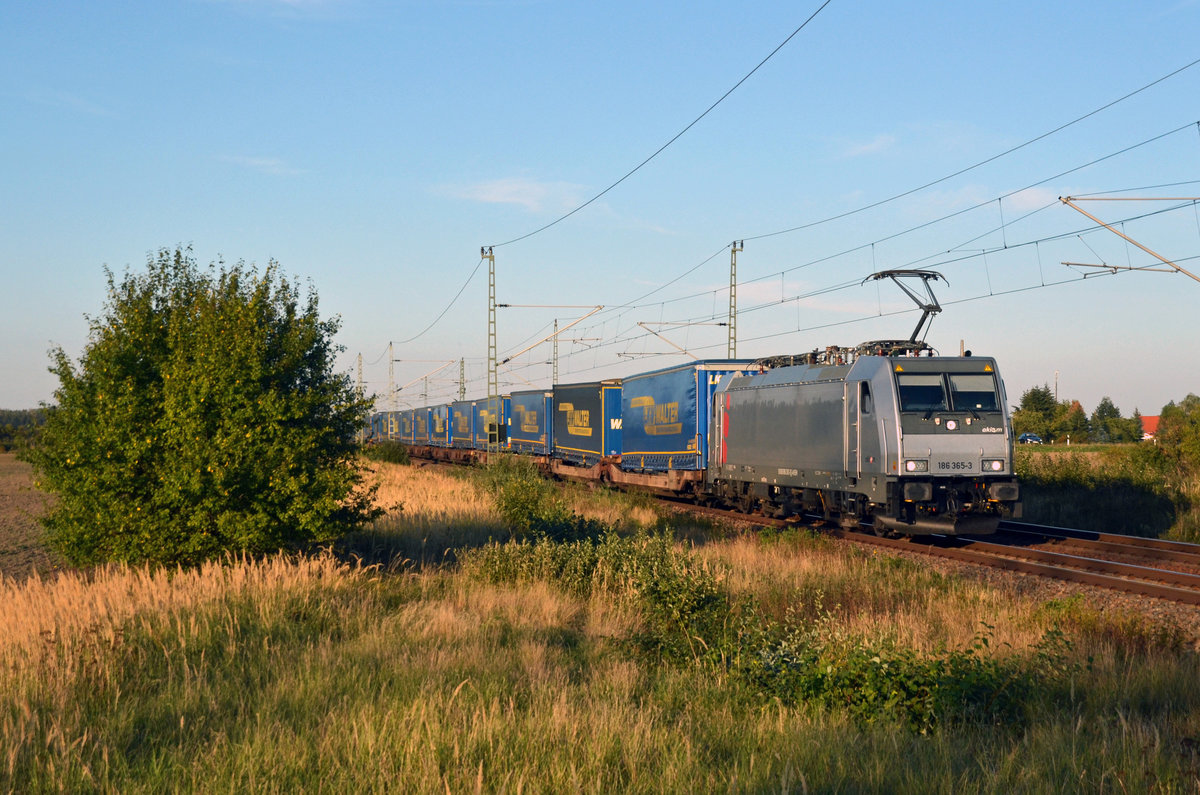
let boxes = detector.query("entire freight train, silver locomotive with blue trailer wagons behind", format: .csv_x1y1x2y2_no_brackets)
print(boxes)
367,341,1020,534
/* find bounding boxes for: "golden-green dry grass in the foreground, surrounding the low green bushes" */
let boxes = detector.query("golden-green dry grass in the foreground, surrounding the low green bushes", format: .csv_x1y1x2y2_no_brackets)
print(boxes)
7,465,1200,793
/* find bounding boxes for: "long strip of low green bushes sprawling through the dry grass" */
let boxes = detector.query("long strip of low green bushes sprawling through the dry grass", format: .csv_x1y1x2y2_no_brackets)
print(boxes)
460,531,1074,733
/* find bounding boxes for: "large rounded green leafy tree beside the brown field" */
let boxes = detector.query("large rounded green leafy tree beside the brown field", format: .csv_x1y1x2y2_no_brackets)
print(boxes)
26,249,374,563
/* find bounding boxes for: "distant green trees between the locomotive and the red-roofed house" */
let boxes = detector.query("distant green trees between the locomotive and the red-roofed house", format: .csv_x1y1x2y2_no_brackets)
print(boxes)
1013,384,1142,444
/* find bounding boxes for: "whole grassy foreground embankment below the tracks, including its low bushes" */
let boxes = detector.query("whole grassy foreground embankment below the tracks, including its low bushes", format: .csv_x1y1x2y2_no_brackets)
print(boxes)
0,465,1200,793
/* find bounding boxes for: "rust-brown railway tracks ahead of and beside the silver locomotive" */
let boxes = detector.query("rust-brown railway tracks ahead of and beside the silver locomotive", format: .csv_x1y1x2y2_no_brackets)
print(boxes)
674,503,1200,605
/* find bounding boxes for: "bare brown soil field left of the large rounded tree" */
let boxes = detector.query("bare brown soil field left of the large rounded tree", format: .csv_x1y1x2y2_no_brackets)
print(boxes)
0,453,62,579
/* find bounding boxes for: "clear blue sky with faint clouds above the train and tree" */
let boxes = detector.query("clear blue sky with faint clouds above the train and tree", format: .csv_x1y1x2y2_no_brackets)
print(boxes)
0,0,1200,416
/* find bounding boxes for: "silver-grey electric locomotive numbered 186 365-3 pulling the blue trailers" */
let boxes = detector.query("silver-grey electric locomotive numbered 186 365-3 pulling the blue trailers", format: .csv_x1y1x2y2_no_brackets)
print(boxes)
706,340,1020,534
